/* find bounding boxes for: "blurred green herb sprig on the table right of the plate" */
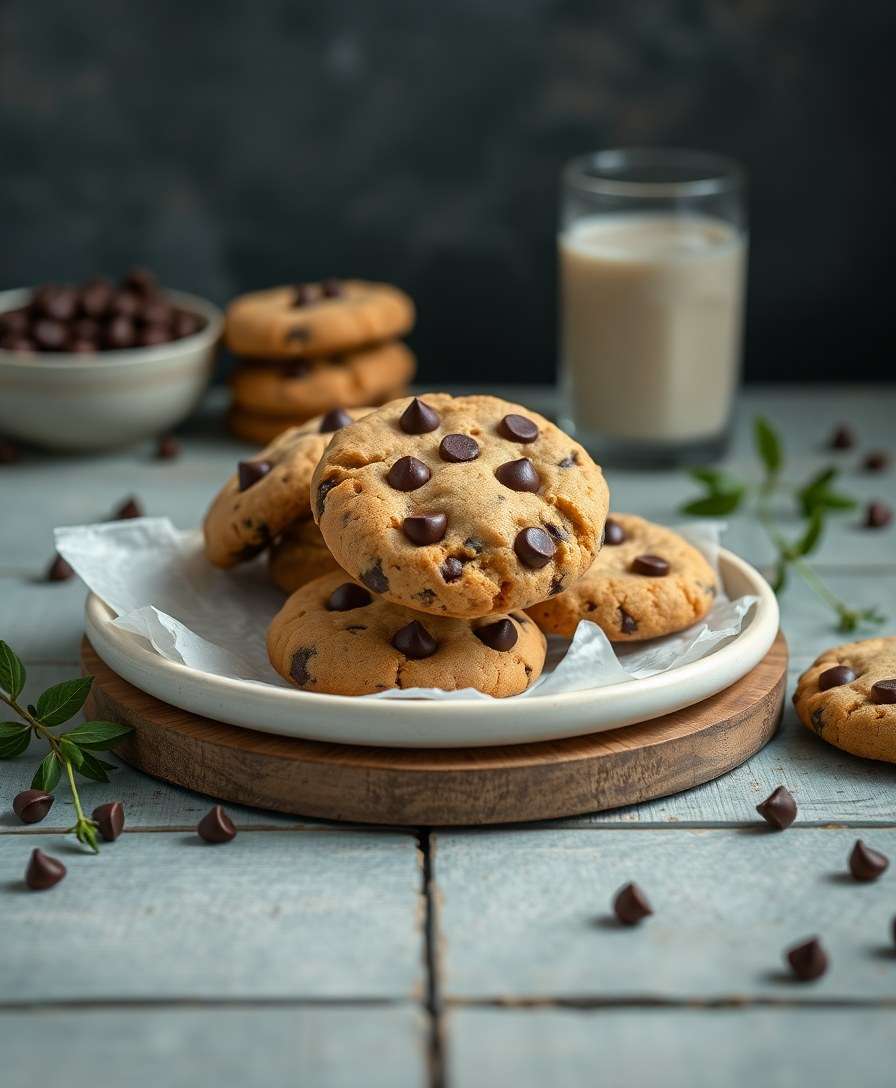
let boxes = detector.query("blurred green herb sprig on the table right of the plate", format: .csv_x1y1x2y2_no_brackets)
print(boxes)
682,416,886,634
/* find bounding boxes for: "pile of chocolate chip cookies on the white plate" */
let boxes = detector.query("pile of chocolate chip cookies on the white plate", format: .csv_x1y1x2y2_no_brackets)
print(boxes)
206,394,715,696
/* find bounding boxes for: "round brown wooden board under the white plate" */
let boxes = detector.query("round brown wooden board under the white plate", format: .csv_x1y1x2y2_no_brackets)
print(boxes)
82,633,787,827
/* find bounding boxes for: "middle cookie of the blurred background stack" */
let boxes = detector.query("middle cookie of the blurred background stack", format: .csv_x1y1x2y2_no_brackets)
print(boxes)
231,343,415,422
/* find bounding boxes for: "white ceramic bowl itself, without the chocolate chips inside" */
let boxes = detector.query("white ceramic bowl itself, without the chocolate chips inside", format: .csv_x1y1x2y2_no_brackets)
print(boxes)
0,288,224,449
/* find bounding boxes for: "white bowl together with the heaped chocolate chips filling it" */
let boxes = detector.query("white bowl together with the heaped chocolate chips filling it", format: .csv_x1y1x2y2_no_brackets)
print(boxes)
0,269,223,449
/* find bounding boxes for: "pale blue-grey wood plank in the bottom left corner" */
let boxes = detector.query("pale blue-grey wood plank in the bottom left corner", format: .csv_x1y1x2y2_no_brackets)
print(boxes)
0,1006,426,1088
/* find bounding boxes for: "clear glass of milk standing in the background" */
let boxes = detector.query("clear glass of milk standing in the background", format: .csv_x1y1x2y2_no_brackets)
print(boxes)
559,149,747,465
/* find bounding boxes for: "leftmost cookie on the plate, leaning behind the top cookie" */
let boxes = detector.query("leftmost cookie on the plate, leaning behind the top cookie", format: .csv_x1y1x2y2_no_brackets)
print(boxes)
202,408,370,567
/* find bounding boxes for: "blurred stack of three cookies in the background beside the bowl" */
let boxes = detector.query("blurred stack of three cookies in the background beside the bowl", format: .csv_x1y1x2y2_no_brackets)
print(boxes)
225,280,415,443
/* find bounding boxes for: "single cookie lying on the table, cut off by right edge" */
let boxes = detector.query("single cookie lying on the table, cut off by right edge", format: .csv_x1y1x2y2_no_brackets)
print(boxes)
794,635,896,763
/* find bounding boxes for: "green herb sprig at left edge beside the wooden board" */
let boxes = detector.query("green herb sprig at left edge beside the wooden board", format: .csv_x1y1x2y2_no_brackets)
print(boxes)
0,640,132,854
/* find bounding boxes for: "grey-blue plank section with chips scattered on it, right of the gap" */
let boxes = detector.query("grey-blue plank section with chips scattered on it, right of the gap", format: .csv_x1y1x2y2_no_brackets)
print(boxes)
435,828,896,1000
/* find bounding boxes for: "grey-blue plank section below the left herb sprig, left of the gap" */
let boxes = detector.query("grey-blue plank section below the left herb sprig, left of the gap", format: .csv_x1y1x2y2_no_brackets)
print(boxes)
0,830,423,1002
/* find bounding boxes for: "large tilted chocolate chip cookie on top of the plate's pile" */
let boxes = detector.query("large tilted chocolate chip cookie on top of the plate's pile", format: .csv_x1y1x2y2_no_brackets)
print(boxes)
311,393,608,618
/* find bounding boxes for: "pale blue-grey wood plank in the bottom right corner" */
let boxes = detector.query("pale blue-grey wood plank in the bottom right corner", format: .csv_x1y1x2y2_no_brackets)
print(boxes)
448,1007,893,1088
